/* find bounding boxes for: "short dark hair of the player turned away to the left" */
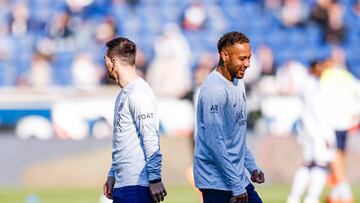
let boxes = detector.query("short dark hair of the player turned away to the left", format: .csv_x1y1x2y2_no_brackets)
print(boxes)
106,37,136,65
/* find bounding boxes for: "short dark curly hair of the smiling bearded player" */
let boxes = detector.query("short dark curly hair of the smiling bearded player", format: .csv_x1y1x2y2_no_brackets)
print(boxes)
217,31,250,53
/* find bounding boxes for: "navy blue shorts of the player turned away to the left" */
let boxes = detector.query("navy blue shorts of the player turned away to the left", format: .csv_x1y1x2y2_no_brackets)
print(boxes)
113,185,154,203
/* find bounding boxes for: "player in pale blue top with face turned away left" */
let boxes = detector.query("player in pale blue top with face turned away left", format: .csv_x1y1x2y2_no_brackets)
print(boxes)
103,37,166,203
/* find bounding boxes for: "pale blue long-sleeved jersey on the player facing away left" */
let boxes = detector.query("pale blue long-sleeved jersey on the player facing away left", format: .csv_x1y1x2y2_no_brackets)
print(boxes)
108,78,162,188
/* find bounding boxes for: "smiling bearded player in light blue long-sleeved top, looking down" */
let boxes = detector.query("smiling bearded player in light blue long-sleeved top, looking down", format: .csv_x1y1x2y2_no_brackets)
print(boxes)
194,32,264,203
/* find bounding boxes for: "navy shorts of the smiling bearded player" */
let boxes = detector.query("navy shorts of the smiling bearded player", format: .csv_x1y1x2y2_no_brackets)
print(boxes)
200,183,262,203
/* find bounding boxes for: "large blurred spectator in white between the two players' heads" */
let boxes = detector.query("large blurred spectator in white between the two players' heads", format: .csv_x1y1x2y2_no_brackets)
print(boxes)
146,24,191,98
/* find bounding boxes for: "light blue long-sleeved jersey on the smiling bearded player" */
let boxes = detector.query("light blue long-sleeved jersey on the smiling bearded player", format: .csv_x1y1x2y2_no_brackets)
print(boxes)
194,70,258,195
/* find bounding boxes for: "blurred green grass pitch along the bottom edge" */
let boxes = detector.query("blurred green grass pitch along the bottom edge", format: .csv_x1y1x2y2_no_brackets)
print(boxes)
0,185,360,203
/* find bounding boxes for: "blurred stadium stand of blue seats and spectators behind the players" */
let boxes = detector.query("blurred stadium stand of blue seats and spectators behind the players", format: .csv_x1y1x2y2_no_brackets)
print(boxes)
0,0,360,89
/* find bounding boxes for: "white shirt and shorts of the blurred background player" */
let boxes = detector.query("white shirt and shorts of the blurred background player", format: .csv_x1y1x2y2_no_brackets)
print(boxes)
300,75,336,166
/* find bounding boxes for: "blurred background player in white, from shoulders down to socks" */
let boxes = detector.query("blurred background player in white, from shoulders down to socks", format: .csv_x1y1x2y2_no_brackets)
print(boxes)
287,75,336,203
